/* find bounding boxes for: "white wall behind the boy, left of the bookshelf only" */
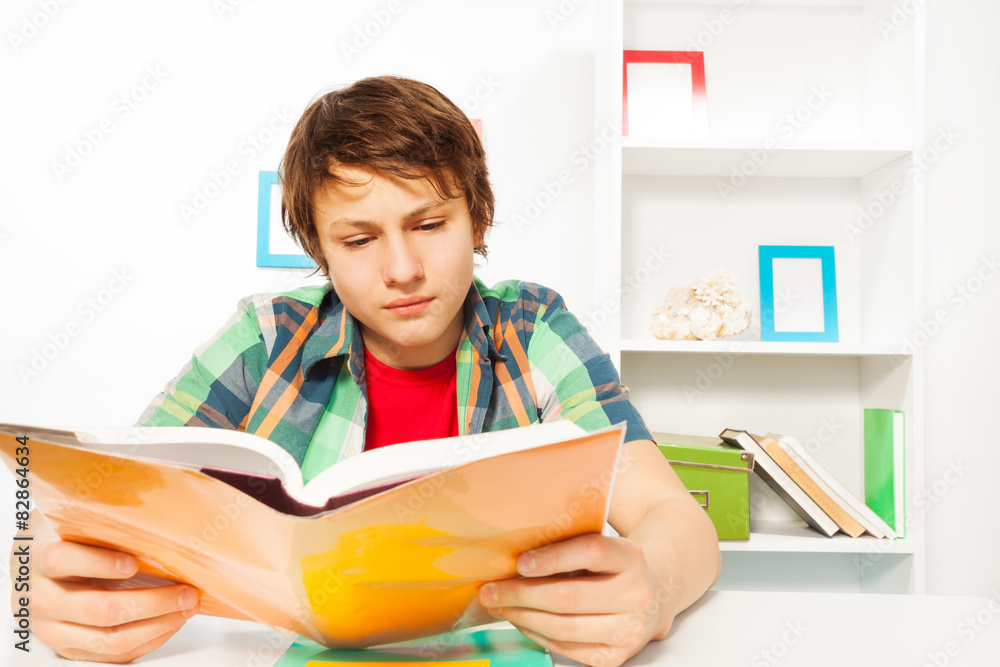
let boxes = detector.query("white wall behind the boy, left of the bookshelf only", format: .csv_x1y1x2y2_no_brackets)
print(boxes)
0,0,595,425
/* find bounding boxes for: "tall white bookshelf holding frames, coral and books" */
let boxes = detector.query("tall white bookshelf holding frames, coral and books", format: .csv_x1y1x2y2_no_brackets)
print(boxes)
591,0,926,593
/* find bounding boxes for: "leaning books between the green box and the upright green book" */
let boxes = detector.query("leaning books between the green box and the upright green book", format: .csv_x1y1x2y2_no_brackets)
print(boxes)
719,429,897,539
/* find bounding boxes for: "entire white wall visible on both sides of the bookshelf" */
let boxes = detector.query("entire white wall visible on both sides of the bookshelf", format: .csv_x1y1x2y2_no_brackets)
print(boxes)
0,0,1000,608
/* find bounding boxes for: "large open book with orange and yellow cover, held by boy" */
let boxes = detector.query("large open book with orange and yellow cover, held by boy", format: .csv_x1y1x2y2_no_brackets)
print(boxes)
0,421,625,648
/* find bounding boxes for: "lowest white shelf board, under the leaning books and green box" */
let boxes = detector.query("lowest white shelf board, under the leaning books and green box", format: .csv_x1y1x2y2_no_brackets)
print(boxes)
719,521,914,558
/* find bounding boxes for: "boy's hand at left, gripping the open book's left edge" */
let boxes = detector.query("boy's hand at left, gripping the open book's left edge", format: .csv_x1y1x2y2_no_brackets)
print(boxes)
11,537,199,662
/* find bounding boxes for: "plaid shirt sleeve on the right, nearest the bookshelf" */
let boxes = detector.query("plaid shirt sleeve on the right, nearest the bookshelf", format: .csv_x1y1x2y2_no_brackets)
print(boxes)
527,291,652,442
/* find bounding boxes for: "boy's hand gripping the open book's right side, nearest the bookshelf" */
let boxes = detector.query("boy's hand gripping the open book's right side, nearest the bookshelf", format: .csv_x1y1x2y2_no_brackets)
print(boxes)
479,535,673,667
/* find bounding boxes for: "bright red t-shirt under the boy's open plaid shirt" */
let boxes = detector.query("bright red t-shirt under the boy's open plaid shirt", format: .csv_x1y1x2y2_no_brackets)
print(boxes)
365,349,458,450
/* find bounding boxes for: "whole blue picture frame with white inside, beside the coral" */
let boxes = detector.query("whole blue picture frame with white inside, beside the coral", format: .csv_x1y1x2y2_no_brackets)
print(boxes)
758,245,840,343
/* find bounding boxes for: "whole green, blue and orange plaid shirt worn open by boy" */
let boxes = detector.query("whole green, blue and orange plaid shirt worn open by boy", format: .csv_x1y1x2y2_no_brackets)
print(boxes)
139,278,651,481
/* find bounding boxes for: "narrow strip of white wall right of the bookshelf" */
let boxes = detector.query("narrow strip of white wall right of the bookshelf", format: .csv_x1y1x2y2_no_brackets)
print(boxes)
924,0,1000,597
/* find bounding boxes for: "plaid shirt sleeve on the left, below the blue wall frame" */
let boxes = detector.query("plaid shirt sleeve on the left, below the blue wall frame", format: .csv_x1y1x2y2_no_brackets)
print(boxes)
138,298,266,430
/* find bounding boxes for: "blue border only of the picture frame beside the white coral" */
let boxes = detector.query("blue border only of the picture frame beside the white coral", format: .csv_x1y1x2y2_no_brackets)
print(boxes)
758,245,840,343
